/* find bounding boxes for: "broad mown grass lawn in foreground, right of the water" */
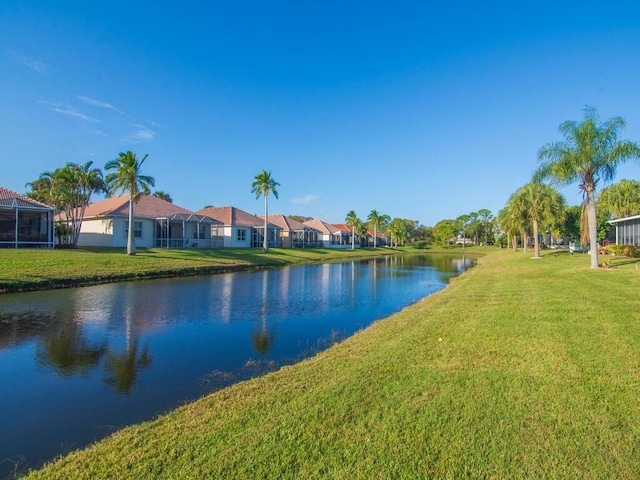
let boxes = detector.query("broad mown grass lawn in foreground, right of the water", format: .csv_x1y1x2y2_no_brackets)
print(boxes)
22,249,640,479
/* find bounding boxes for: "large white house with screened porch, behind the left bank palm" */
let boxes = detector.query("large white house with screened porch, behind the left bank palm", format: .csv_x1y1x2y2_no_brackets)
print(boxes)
78,194,222,248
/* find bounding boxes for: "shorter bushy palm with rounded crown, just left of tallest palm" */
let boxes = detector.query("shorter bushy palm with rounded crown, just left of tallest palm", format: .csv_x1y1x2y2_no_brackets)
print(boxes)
523,183,565,258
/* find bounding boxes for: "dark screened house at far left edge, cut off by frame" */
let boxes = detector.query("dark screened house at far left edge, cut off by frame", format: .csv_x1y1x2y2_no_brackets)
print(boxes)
0,187,55,248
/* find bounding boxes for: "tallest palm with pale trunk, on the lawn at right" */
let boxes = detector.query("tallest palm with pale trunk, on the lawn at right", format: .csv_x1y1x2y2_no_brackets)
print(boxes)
534,106,640,268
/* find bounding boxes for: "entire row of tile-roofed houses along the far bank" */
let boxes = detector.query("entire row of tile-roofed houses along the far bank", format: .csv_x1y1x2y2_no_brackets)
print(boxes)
0,187,388,248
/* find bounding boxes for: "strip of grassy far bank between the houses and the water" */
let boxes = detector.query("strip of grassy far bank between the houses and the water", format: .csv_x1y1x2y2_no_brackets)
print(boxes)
0,247,393,293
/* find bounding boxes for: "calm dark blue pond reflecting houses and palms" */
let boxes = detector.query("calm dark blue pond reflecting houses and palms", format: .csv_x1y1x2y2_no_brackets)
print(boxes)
0,255,472,478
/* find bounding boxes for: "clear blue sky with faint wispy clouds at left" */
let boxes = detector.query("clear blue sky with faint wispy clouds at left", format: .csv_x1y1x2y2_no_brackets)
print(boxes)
0,0,640,226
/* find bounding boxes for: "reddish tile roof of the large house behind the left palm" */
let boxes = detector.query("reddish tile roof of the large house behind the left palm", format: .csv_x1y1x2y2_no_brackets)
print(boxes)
84,194,215,222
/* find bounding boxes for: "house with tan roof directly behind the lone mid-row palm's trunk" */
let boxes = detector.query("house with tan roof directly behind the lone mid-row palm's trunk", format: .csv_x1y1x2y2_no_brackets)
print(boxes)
197,207,282,248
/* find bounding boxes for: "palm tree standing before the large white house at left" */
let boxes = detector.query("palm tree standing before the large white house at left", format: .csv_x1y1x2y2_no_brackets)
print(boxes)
104,151,156,255
